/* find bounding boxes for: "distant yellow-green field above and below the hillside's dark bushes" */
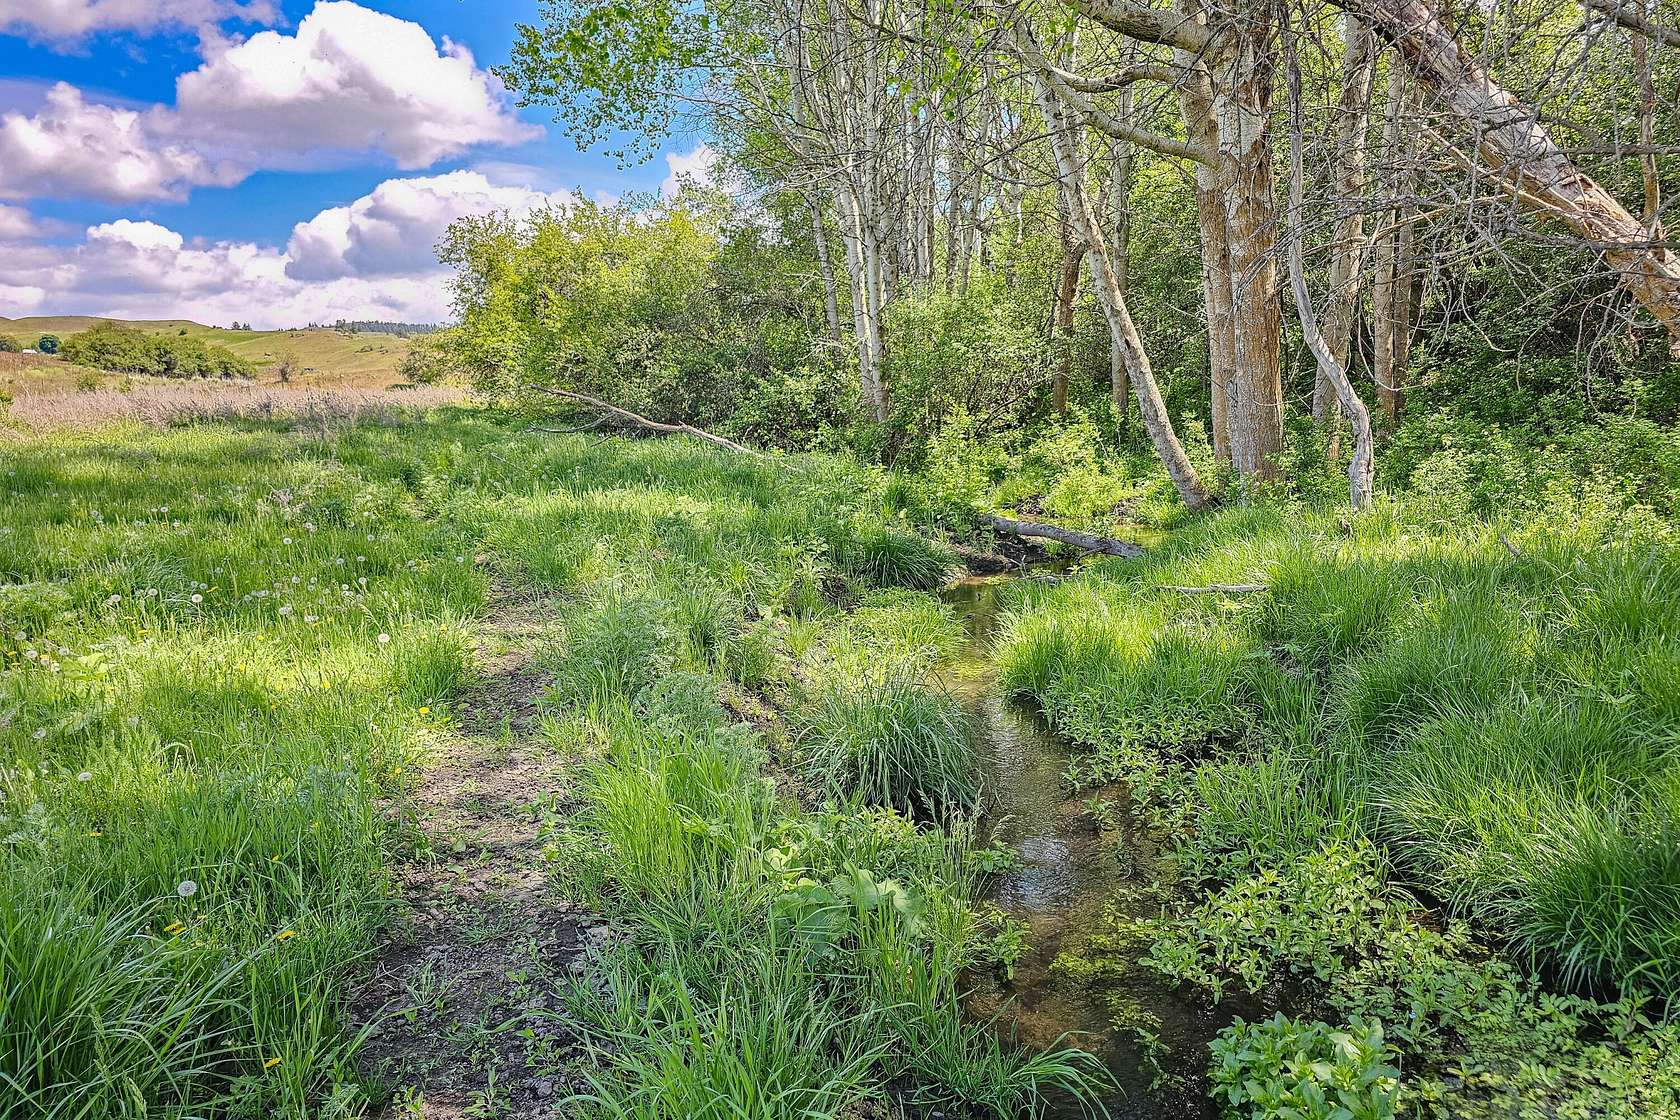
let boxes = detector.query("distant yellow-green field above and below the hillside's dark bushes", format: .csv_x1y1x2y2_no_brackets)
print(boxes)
0,316,408,395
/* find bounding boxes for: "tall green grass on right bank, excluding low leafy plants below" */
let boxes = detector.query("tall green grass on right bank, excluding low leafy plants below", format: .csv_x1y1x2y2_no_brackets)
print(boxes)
998,505,1680,997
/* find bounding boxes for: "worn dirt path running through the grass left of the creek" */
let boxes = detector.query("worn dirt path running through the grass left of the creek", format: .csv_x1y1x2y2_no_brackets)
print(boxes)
353,588,588,1120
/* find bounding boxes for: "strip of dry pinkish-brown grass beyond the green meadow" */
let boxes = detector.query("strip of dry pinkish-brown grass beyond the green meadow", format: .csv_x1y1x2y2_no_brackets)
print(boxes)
0,379,465,437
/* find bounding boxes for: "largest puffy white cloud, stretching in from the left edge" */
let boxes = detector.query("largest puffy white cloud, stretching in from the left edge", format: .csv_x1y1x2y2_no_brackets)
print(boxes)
0,0,541,201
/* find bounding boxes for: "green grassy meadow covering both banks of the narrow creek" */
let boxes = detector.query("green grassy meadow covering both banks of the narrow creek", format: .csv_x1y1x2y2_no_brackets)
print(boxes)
0,397,1680,1120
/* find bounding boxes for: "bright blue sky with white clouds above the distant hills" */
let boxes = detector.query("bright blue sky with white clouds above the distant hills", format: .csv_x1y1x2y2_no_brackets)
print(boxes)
0,0,709,329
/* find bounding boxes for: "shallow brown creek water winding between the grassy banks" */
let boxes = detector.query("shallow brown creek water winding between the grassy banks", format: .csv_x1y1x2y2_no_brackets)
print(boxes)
941,574,1231,1120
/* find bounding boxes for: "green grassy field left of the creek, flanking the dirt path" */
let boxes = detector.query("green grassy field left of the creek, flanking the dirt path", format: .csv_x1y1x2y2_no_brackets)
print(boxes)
0,410,1092,1118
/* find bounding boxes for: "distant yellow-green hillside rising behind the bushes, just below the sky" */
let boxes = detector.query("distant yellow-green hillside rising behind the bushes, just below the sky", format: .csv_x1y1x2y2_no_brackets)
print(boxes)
0,316,408,388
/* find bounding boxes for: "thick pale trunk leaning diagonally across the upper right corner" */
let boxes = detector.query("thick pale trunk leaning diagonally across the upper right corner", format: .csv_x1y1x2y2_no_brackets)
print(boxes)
1339,0,1680,356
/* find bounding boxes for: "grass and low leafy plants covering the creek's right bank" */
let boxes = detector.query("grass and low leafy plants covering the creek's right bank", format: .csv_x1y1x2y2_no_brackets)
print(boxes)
998,497,1680,1117
